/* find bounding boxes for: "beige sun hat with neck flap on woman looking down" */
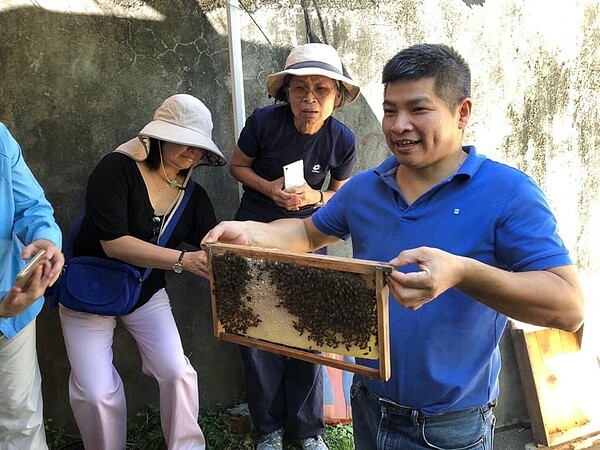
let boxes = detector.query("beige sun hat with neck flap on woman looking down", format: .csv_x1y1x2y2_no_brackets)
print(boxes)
115,94,227,166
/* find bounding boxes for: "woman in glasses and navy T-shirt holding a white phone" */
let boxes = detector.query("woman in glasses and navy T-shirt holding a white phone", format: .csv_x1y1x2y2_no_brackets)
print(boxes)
230,44,360,450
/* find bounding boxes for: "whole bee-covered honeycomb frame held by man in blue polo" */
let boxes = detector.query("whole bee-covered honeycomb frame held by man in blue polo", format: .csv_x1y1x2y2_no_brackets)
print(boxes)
205,244,393,380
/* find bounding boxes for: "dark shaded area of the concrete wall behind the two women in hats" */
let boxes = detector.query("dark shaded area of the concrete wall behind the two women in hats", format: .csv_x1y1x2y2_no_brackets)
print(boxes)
0,0,387,424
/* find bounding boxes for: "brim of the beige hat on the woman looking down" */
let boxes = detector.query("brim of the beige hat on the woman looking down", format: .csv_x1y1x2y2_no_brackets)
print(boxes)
138,120,227,166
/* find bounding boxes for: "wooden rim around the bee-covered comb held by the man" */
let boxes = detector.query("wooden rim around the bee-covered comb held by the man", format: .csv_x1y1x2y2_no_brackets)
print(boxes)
203,244,393,381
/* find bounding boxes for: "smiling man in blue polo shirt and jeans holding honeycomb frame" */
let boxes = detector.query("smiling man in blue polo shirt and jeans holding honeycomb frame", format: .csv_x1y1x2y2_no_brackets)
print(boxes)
204,44,583,450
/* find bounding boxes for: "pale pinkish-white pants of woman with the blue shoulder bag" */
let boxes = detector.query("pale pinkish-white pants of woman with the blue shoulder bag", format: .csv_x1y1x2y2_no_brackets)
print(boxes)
60,289,205,450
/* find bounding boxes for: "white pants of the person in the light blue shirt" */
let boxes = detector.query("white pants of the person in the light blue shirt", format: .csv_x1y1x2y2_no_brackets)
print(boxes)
0,320,48,450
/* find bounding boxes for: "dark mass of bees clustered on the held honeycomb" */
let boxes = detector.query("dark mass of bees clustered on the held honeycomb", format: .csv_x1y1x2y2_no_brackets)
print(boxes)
212,252,377,355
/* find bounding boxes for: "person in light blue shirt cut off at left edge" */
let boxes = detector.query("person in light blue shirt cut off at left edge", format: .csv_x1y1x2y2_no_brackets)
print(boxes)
0,123,64,450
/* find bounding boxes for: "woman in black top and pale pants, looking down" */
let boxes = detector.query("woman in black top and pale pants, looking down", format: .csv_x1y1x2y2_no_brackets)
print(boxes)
59,94,225,450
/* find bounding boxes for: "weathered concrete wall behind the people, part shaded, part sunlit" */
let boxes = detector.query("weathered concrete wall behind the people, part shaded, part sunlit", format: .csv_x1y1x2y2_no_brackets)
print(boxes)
0,0,600,426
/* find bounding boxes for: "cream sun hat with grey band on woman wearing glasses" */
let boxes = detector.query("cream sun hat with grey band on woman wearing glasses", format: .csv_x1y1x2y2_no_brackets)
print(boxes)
266,43,360,106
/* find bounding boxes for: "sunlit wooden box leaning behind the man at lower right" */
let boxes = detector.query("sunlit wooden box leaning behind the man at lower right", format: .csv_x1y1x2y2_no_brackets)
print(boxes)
511,322,600,448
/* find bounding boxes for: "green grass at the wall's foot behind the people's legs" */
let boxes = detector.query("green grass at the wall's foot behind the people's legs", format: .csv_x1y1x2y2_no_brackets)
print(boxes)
46,405,354,450
